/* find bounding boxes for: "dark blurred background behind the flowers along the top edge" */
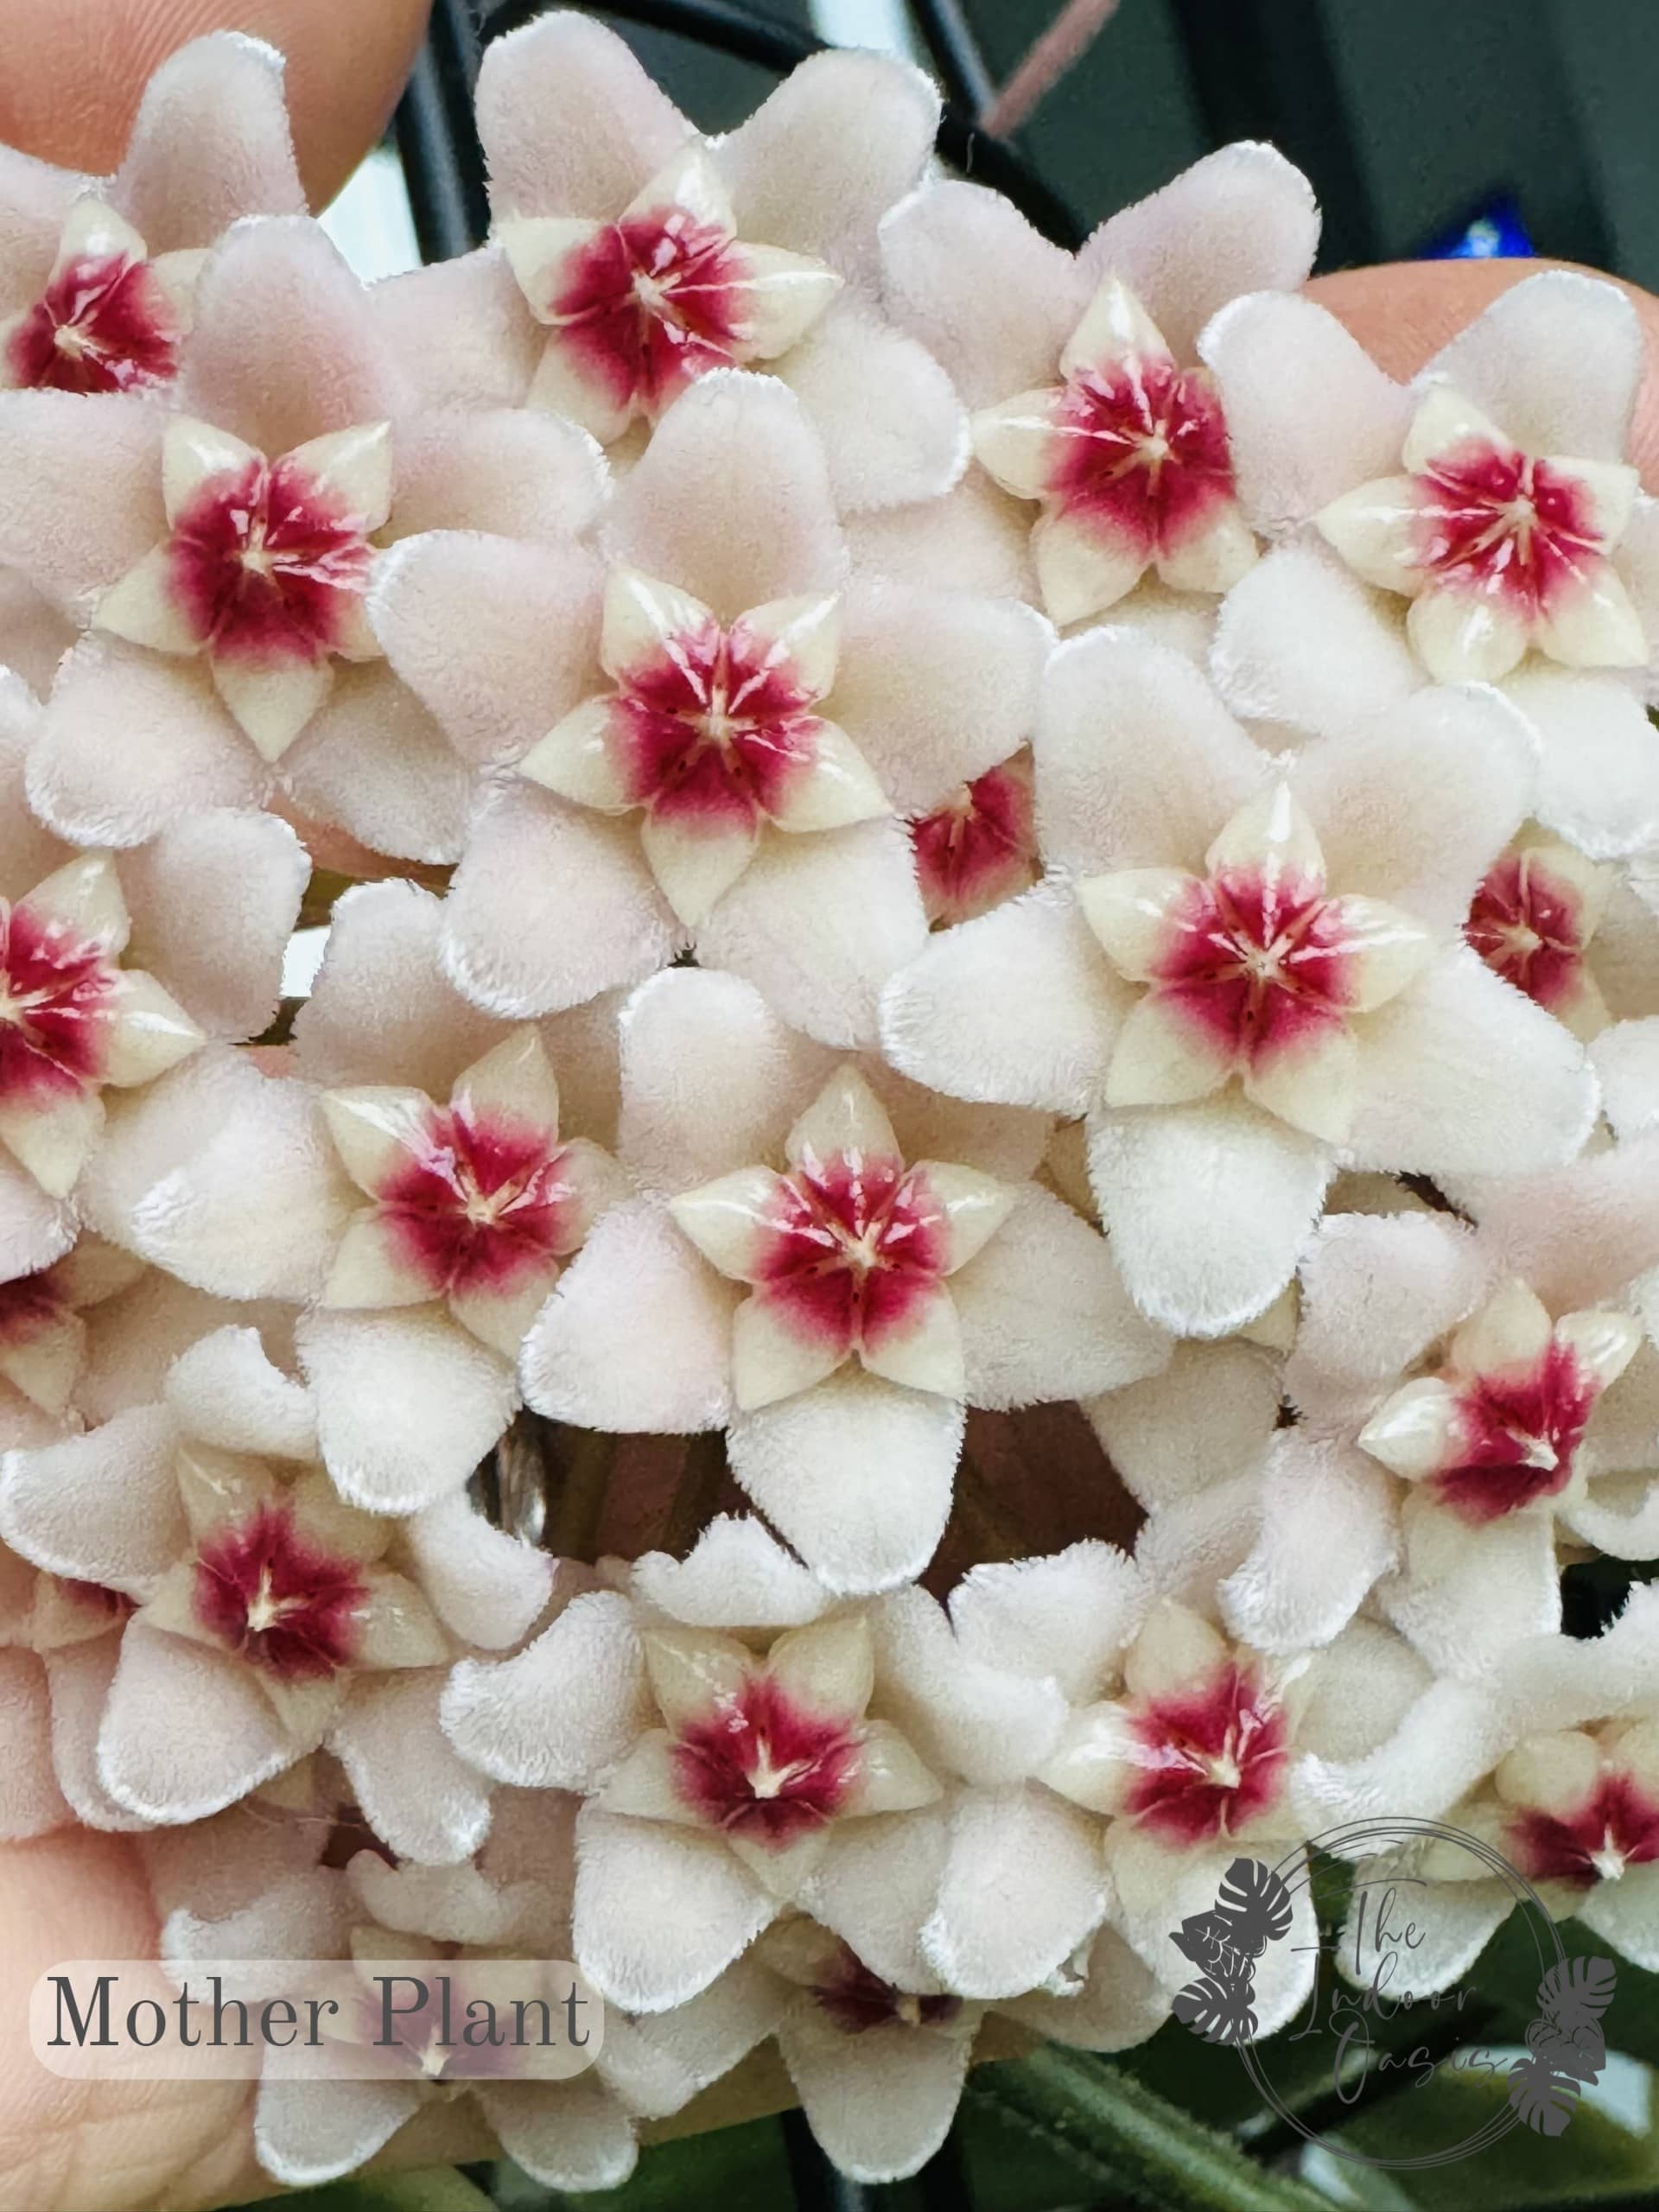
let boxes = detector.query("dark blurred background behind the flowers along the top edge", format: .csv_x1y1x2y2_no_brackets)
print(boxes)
332,0,1659,288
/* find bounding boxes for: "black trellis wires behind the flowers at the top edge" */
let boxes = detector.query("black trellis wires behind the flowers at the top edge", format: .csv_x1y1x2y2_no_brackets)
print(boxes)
396,0,1084,261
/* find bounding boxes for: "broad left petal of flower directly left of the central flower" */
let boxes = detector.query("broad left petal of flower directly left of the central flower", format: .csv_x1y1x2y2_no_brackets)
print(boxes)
82,1048,352,1299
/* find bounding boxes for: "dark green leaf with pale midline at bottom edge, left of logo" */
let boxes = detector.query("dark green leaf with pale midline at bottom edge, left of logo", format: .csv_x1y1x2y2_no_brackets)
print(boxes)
964,2046,1330,2212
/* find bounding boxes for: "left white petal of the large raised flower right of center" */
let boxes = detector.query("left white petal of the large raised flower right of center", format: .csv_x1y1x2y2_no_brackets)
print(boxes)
880,885,1130,1113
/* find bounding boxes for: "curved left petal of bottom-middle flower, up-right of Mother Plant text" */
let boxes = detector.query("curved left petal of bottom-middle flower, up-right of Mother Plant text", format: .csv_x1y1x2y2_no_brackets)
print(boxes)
442,1591,652,1792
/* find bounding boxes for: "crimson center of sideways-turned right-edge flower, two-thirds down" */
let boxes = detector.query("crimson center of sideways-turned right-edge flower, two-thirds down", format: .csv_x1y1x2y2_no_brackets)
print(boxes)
1433,1340,1599,1522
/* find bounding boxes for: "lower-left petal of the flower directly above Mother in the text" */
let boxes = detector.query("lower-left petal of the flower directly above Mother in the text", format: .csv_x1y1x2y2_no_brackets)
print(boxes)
98,1624,309,1821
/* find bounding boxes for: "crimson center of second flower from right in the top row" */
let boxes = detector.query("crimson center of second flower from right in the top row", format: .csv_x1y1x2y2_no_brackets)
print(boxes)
1048,356,1234,557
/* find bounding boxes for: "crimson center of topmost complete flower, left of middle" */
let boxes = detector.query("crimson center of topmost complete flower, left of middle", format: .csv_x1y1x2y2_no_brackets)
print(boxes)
549,208,747,414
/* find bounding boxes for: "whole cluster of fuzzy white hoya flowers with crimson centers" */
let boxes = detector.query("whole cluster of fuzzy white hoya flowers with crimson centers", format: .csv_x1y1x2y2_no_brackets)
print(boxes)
0,16,1659,2190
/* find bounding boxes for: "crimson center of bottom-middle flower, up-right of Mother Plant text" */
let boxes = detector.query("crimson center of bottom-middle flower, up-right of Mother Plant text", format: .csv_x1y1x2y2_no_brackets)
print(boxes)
672,1675,858,1849
